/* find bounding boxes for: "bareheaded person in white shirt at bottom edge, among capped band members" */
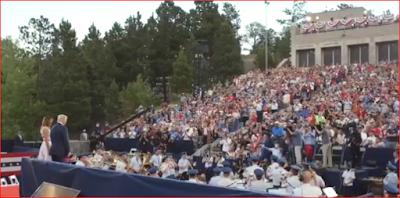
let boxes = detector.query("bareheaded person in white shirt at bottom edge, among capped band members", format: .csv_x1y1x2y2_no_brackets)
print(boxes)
293,170,322,197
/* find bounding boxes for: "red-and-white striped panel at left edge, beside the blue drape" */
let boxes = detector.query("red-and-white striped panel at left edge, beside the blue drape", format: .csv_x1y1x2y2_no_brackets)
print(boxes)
1,153,37,177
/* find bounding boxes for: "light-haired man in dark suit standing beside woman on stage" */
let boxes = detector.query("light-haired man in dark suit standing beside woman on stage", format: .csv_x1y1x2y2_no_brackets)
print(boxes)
49,114,70,162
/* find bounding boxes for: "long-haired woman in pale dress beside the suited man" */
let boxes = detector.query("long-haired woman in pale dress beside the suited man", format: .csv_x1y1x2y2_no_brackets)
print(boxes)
38,116,54,161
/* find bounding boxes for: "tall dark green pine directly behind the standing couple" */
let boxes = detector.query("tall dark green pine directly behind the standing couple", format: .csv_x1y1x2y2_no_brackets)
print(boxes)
47,20,91,131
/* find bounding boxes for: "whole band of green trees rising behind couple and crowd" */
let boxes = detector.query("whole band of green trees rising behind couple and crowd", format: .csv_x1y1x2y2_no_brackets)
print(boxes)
1,1,318,139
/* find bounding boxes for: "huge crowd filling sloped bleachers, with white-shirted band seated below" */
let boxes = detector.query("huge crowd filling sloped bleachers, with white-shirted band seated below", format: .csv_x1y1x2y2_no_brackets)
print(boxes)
38,62,399,196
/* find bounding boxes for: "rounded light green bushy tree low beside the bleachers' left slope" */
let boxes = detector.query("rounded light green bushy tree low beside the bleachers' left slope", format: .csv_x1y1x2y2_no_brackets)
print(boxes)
119,75,156,116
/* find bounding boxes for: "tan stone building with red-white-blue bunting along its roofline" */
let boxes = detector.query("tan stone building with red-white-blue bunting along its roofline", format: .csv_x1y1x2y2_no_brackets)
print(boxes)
291,8,399,66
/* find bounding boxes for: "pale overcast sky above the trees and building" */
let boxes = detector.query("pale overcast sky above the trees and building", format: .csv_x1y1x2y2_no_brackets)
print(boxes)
1,1,399,53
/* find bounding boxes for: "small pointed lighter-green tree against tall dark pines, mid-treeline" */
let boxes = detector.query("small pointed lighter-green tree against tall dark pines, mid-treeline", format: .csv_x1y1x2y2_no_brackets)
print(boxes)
171,50,194,93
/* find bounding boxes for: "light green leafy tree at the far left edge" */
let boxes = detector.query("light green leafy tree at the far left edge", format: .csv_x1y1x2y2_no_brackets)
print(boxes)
1,38,43,139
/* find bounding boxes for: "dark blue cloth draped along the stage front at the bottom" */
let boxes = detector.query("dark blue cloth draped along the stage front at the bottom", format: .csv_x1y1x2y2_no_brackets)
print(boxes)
21,159,288,197
